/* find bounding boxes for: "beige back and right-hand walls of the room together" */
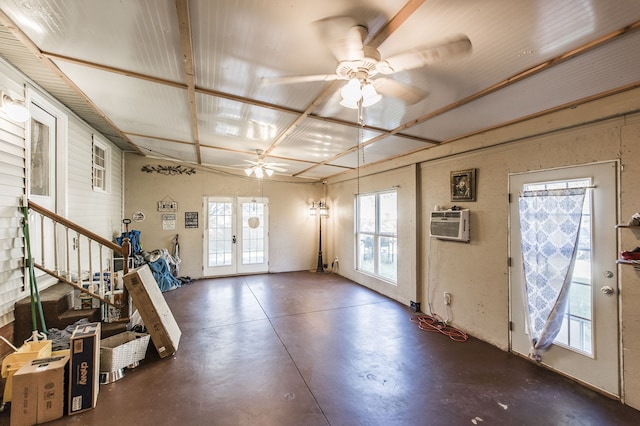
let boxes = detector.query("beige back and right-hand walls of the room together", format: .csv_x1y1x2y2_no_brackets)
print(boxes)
125,89,640,408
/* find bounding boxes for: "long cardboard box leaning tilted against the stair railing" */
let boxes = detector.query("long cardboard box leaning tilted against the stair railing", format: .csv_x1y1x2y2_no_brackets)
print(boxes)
123,265,182,358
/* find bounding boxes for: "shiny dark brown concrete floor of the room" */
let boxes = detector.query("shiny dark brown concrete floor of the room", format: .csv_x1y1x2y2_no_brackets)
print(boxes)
0,272,640,426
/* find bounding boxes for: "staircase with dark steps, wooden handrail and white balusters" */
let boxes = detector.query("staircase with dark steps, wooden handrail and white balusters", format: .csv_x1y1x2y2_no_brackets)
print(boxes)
13,200,131,346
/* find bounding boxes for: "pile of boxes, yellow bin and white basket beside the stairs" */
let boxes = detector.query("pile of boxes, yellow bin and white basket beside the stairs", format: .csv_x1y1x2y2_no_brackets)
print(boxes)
2,264,181,426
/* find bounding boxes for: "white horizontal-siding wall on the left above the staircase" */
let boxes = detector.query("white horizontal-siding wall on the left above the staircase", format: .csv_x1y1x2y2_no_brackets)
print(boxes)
0,59,123,327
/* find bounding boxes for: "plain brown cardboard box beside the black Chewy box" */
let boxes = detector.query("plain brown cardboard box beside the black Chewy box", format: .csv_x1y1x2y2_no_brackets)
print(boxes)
11,355,69,426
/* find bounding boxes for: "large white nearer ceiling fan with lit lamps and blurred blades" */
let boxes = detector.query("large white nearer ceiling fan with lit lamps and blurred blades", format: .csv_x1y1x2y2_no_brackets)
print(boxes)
263,16,472,109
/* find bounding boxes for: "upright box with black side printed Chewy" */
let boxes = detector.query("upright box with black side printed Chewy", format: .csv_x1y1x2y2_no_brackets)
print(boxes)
67,322,100,414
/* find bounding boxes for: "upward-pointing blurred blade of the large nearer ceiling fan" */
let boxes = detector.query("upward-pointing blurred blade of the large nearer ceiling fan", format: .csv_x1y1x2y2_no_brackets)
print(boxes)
316,16,368,62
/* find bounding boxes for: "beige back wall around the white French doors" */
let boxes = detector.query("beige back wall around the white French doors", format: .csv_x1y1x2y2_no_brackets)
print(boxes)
124,154,327,278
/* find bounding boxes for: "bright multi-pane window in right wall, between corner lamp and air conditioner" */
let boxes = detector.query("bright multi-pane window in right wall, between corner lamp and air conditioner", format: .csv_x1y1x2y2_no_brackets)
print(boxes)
356,190,398,284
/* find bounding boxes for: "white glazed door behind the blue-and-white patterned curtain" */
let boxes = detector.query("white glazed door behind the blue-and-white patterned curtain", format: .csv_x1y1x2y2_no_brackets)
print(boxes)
509,162,620,396
